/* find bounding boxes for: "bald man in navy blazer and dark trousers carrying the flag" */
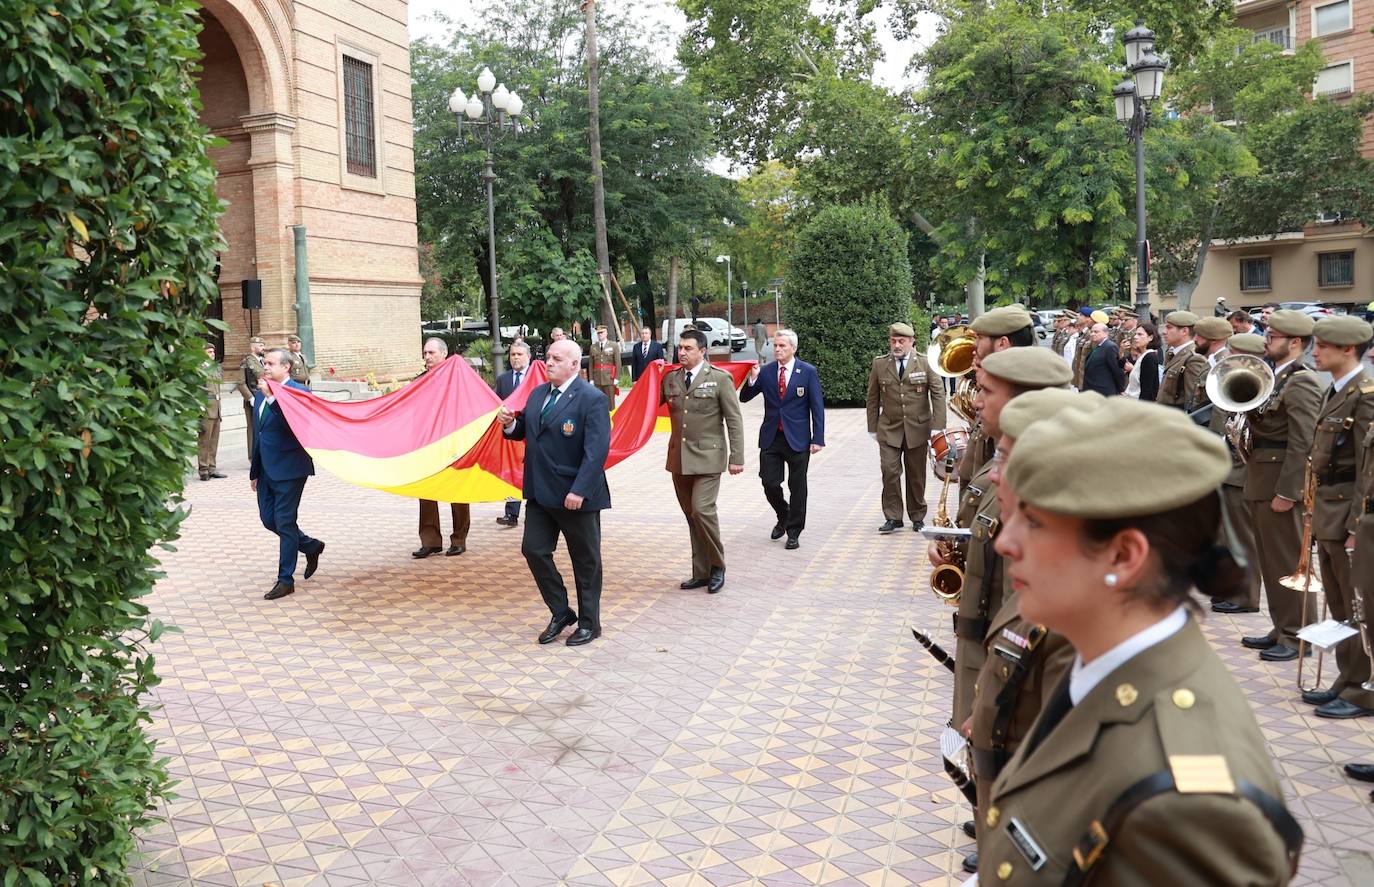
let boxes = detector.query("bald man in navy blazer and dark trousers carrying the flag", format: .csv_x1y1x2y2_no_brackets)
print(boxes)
496,339,610,647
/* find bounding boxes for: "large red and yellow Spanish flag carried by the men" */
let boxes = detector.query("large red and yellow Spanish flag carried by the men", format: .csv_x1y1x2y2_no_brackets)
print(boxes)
269,358,753,503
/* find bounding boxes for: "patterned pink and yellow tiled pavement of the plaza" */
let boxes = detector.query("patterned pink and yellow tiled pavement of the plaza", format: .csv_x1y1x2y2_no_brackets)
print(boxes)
135,404,1374,887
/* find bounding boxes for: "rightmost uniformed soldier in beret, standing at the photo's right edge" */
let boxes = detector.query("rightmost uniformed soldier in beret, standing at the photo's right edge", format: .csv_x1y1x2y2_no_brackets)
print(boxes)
1303,316,1374,718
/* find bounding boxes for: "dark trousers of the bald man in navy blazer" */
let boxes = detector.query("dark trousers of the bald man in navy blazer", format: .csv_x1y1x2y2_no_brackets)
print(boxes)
519,500,602,629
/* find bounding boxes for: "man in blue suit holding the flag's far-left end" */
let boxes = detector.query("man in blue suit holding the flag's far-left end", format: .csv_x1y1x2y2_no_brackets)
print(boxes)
249,347,324,600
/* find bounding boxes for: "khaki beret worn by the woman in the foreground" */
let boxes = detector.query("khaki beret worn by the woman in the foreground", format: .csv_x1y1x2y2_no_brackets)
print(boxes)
1003,400,1231,518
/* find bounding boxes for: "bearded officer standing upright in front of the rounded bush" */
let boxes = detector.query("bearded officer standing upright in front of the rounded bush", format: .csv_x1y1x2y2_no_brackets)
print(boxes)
864,323,945,533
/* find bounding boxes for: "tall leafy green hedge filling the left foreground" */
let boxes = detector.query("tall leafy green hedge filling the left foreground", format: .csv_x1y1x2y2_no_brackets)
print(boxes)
0,0,220,887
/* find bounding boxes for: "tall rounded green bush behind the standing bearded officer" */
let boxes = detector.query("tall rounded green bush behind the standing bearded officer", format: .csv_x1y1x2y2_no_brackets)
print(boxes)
787,205,912,404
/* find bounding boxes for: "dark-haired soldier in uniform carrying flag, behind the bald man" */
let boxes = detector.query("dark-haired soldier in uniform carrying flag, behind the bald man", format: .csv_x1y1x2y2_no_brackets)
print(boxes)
660,330,745,595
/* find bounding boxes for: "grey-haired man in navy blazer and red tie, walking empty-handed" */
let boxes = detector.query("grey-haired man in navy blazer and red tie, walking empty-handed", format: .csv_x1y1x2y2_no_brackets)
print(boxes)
739,330,826,548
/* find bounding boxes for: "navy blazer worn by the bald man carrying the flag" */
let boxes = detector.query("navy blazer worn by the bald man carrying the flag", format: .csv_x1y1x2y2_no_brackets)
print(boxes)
506,378,610,511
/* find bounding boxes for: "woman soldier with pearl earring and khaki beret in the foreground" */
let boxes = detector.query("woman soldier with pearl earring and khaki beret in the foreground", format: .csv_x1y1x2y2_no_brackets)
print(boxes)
978,397,1303,887
